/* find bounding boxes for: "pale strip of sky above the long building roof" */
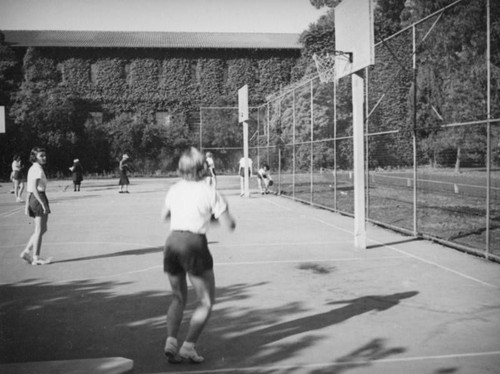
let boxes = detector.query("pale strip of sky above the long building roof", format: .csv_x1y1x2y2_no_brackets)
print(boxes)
0,0,327,33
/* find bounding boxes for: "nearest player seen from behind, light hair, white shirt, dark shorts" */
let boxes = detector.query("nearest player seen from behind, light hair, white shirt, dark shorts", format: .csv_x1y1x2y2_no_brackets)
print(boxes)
161,147,236,363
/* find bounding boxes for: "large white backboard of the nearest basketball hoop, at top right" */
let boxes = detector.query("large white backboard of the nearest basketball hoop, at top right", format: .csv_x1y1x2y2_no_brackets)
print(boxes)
335,0,375,79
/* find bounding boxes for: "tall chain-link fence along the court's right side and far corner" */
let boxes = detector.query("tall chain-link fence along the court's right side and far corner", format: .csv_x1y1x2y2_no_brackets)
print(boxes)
200,0,500,260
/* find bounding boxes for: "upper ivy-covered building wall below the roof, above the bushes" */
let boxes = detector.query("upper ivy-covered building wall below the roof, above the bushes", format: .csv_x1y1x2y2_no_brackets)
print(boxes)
29,48,300,114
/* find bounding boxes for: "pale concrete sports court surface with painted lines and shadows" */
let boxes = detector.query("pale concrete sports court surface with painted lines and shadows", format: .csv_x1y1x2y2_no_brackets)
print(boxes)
0,177,500,374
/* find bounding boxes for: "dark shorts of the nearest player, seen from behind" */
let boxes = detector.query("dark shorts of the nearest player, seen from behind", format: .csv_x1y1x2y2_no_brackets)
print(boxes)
163,231,214,276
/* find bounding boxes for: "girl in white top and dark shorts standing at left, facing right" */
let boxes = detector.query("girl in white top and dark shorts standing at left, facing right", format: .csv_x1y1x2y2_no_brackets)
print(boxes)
20,147,50,265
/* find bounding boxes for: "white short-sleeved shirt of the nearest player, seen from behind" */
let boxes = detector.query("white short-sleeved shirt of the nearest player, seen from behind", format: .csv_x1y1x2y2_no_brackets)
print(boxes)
165,180,227,234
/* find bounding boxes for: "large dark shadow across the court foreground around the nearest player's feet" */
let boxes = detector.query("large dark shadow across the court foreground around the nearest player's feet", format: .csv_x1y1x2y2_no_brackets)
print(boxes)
0,280,418,373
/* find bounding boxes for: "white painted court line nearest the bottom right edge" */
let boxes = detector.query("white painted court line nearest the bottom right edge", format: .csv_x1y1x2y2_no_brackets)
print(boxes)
169,351,500,374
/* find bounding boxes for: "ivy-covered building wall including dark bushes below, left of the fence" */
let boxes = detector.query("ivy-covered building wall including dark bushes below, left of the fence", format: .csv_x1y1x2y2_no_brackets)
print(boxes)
0,43,300,176
